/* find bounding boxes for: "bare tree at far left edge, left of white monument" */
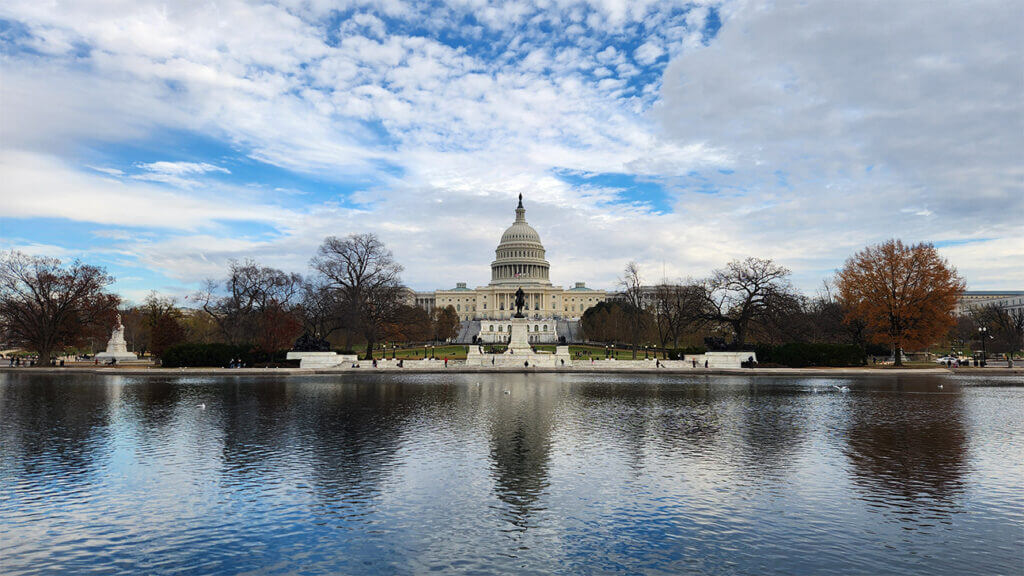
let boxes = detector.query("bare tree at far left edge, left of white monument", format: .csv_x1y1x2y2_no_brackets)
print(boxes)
0,251,120,366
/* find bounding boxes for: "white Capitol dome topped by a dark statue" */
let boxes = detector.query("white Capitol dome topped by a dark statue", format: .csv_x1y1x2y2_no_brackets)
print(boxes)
490,194,551,286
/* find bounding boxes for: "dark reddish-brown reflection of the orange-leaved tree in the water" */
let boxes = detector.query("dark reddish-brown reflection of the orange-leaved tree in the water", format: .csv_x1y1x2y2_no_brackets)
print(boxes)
847,379,967,502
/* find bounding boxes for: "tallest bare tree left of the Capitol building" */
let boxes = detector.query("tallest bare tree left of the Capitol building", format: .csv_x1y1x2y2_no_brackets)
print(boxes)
310,234,407,358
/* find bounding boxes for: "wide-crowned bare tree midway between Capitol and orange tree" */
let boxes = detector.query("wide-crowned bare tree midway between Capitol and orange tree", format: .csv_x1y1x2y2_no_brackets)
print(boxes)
700,258,799,346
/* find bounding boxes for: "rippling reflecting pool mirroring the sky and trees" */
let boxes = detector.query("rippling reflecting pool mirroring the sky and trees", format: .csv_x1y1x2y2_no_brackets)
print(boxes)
0,371,1024,574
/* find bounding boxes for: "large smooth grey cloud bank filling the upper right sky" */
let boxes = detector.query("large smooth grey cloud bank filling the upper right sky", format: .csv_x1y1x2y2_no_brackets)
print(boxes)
656,2,1024,287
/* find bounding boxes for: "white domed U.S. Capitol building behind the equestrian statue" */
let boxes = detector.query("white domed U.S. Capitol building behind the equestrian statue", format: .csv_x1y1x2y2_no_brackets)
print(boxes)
415,195,607,342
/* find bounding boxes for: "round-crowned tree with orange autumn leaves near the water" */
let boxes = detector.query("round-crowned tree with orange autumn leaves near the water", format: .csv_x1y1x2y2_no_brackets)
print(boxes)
836,240,965,366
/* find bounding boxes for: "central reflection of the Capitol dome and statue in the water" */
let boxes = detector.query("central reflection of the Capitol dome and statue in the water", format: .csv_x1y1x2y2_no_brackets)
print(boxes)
488,378,557,529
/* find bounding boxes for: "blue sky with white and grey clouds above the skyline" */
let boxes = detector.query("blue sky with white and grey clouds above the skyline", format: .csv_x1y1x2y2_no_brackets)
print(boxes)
0,0,1024,298
